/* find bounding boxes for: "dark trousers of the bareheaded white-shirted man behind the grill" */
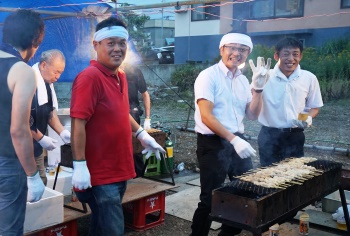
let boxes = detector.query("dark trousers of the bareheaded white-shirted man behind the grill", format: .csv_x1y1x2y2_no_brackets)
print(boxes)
258,126,305,166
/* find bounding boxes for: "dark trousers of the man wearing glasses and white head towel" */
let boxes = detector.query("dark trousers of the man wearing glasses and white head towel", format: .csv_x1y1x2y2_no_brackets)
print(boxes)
191,134,253,236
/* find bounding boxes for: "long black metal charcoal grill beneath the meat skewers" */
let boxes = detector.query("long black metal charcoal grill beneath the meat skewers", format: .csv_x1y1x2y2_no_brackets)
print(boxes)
211,160,349,235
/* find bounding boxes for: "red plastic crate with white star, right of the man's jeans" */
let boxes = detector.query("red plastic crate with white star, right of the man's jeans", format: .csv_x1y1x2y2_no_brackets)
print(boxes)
123,191,165,231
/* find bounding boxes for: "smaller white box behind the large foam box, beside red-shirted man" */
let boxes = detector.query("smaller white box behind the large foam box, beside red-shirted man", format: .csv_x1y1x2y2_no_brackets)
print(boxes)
46,169,73,196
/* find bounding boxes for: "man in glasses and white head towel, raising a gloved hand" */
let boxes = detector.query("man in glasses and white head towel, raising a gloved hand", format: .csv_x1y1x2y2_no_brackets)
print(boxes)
191,33,271,236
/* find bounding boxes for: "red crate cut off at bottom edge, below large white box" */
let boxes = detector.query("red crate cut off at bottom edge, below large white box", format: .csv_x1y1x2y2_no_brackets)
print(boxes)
26,220,78,236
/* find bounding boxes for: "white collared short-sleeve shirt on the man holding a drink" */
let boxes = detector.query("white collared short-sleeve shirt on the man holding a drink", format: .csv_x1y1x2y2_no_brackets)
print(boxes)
258,63,323,128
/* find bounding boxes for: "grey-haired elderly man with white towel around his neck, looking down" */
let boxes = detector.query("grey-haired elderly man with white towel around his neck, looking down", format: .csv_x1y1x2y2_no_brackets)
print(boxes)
31,49,70,185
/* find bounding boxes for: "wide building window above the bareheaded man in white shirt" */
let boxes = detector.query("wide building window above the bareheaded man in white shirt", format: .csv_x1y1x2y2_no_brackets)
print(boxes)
250,0,304,19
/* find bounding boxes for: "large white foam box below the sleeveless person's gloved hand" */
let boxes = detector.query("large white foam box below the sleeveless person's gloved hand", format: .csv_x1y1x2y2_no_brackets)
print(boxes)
24,187,63,233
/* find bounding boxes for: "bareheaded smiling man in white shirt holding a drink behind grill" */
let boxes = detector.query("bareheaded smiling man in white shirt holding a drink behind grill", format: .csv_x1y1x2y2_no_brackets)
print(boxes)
258,37,323,166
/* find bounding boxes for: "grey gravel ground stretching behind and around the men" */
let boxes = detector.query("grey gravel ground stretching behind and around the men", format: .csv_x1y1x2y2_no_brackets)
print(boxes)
63,96,350,236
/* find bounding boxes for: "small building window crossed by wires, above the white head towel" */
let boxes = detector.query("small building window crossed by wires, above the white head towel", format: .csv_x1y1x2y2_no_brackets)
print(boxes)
191,2,220,21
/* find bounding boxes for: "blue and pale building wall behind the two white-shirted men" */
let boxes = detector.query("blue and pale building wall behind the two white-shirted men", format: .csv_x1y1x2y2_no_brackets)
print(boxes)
175,0,350,64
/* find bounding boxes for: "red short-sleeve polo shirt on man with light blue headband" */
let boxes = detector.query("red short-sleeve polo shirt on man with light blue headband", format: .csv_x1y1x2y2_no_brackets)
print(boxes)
70,60,136,186
